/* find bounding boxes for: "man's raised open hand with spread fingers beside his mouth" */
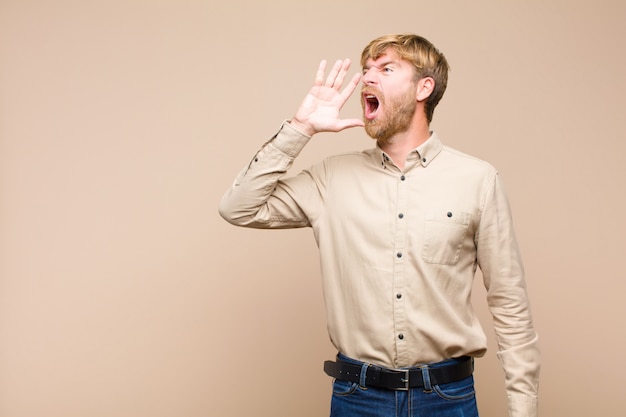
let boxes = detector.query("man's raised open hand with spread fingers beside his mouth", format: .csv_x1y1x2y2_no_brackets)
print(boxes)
290,59,364,136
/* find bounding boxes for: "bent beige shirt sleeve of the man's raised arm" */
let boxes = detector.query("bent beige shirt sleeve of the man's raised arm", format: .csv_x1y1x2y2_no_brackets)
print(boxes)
219,122,311,228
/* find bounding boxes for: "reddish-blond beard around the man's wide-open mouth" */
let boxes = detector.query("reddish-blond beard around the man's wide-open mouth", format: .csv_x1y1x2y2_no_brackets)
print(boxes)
363,88,417,144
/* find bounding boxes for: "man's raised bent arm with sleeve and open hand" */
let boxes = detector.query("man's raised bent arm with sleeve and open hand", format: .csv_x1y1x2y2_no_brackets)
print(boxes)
219,60,363,228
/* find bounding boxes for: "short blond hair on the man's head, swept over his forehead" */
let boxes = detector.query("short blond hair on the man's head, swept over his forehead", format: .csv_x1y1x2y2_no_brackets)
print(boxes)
361,33,450,123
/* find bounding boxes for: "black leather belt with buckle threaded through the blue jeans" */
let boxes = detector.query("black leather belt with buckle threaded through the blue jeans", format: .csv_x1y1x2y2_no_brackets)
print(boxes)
324,356,474,390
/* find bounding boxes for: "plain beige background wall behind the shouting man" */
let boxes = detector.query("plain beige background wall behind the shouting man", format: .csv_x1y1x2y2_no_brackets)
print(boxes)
0,0,626,417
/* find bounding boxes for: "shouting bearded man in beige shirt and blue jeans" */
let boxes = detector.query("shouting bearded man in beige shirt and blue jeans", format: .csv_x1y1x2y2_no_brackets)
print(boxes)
220,34,539,417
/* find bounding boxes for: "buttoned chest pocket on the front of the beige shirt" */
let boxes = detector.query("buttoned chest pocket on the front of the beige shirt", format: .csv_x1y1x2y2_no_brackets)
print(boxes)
422,209,470,265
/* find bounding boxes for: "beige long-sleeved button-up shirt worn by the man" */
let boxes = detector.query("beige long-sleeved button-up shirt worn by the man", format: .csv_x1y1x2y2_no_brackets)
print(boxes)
220,123,539,417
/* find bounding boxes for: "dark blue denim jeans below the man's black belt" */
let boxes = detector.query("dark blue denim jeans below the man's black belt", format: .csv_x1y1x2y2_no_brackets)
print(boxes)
330,353,478,417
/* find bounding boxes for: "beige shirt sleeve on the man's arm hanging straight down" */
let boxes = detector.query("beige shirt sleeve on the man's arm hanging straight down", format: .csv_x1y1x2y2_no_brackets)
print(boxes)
476,173,541,417
